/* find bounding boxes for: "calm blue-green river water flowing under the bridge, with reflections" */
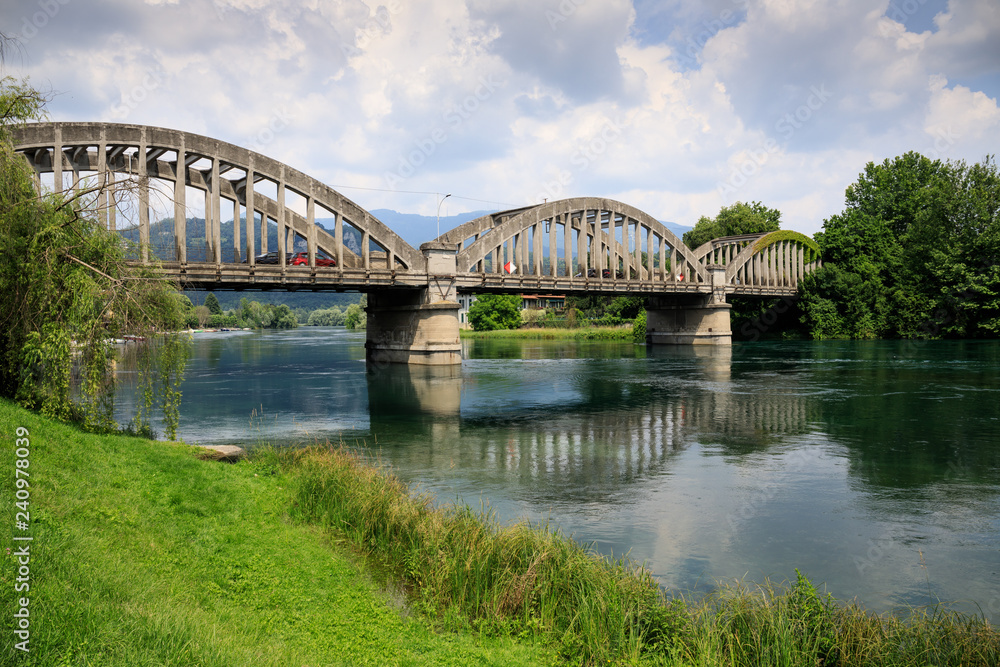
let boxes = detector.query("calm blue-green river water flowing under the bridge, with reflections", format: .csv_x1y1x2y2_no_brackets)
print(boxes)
113,328,1000,623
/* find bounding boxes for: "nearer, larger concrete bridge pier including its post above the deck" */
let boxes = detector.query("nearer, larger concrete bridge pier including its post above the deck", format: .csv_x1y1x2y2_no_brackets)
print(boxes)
365,243,462,366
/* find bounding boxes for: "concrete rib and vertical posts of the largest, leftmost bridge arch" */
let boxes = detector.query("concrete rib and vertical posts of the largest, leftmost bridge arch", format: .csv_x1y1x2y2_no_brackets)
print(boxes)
13,122,424,271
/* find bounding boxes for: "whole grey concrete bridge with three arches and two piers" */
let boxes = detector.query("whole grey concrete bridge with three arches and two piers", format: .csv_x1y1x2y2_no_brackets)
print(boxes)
14,122,820,365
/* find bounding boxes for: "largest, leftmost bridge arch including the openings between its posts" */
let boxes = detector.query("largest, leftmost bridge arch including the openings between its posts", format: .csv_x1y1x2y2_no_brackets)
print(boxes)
14,123,423,271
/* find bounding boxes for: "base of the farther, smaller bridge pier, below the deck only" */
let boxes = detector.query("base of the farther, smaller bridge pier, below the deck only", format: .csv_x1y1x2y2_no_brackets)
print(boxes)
646,297,733,346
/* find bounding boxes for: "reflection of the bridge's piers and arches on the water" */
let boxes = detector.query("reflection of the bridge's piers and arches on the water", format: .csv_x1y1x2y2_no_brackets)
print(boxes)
367,347,819,503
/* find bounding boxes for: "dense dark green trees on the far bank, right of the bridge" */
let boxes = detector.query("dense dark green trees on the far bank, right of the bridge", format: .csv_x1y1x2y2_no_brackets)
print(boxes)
801,152,1000,339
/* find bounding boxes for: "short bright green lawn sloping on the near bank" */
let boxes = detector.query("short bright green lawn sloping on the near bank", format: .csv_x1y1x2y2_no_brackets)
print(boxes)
0,402,555,667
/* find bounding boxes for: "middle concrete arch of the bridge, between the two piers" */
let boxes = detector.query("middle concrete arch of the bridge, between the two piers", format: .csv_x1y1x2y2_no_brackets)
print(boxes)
454,197,708,283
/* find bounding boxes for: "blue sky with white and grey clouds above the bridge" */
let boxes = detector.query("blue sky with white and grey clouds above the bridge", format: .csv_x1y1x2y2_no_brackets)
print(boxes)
7,0,1000,240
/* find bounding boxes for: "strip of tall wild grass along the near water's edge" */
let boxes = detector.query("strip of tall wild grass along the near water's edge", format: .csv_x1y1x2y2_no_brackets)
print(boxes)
284,447,1000,667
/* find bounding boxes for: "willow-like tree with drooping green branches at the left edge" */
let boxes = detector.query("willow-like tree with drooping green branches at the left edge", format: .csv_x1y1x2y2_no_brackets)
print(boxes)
0,77,187,437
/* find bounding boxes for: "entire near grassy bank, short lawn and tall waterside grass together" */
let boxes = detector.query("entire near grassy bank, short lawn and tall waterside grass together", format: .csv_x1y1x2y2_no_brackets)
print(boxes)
7,401,1000,667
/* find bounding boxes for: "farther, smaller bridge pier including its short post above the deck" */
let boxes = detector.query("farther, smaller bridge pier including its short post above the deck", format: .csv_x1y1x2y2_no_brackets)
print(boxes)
646,264,733,345
